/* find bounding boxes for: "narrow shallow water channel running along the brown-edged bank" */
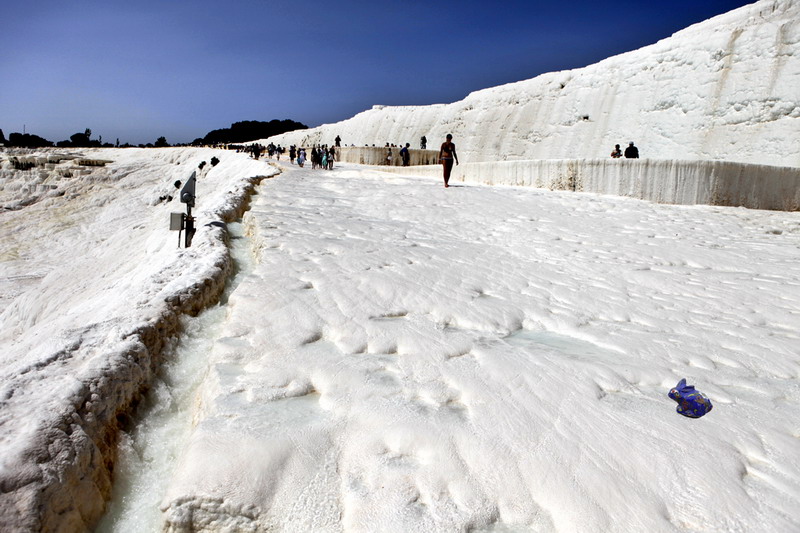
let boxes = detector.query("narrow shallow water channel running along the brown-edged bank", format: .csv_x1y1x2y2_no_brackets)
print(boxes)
96,223,254,533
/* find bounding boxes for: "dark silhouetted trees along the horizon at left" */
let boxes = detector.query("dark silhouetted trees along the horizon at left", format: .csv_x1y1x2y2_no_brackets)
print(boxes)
0,119,308,148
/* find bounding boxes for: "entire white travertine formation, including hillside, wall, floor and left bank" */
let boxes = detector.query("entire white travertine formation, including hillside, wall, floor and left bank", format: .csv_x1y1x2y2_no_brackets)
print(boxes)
0,0,800,533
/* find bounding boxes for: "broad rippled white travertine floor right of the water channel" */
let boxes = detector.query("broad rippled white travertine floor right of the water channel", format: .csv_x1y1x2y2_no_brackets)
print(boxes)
163,162,800,533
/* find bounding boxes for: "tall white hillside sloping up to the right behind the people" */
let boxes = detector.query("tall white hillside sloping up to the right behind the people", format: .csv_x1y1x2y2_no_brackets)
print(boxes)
262,0,800,167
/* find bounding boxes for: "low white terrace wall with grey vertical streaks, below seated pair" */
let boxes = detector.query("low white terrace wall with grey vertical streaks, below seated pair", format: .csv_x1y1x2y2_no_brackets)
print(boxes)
381,159,800,211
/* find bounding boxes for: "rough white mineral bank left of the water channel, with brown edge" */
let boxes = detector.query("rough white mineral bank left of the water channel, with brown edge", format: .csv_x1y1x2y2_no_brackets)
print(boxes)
0,148,276,531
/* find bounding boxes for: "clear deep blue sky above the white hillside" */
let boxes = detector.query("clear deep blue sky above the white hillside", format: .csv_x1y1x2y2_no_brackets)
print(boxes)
0,0,752,144
